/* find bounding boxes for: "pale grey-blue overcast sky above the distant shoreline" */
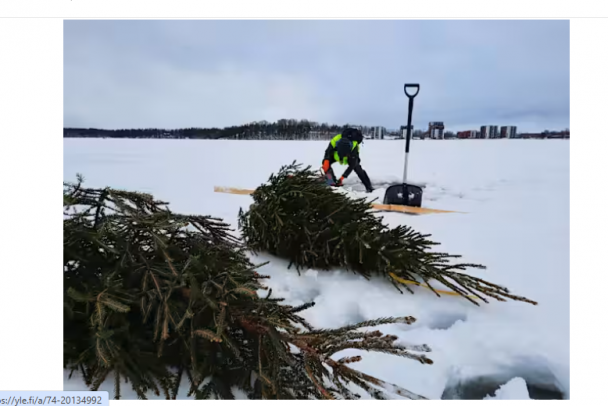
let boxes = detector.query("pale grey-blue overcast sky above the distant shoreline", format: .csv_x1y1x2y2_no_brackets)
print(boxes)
64,20,570,131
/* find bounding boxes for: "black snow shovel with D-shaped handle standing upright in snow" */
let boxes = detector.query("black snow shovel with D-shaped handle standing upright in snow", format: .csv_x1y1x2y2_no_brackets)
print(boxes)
384,83,422,207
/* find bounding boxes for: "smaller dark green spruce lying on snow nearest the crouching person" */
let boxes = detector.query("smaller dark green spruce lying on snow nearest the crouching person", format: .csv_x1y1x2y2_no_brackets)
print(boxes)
239,162,536,305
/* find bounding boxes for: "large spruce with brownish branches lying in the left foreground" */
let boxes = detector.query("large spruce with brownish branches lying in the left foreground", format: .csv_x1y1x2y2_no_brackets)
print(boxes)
63,178,432,399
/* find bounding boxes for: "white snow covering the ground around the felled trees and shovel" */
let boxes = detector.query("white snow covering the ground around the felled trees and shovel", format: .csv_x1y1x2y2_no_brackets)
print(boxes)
64,139,570,399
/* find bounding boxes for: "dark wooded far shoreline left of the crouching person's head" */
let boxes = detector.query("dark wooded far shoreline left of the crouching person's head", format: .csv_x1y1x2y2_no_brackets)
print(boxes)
63,119,358,140
